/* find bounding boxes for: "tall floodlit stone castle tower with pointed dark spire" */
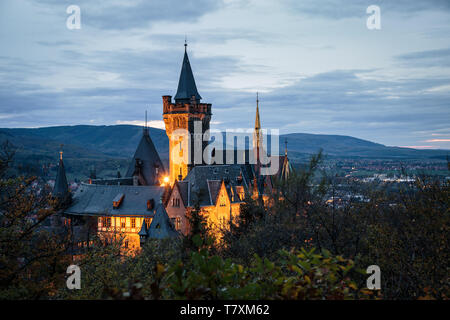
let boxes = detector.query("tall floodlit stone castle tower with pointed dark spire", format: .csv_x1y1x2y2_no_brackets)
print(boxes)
163,43,211,185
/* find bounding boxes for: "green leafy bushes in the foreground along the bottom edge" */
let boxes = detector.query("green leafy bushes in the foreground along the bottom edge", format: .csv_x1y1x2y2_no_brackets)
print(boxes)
61,237,371,300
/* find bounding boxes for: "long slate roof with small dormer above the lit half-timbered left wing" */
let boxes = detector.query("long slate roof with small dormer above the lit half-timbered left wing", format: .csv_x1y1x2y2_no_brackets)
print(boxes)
66,183,165,217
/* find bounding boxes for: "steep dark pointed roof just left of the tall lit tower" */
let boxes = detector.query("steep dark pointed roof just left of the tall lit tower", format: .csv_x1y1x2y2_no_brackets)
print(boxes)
126,129,165,186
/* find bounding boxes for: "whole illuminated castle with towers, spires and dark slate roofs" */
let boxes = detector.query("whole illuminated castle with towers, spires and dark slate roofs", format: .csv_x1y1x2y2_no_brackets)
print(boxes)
53,44,292,249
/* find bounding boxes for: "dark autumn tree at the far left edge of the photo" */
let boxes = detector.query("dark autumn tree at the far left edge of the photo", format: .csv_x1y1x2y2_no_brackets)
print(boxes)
0,144,70,299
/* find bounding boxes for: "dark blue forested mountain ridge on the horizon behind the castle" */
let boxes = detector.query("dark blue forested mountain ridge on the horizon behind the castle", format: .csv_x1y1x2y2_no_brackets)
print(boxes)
0,125,450,160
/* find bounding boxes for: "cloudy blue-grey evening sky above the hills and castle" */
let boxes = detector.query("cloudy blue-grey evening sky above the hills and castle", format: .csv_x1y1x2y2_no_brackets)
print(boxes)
0,0,450,149
